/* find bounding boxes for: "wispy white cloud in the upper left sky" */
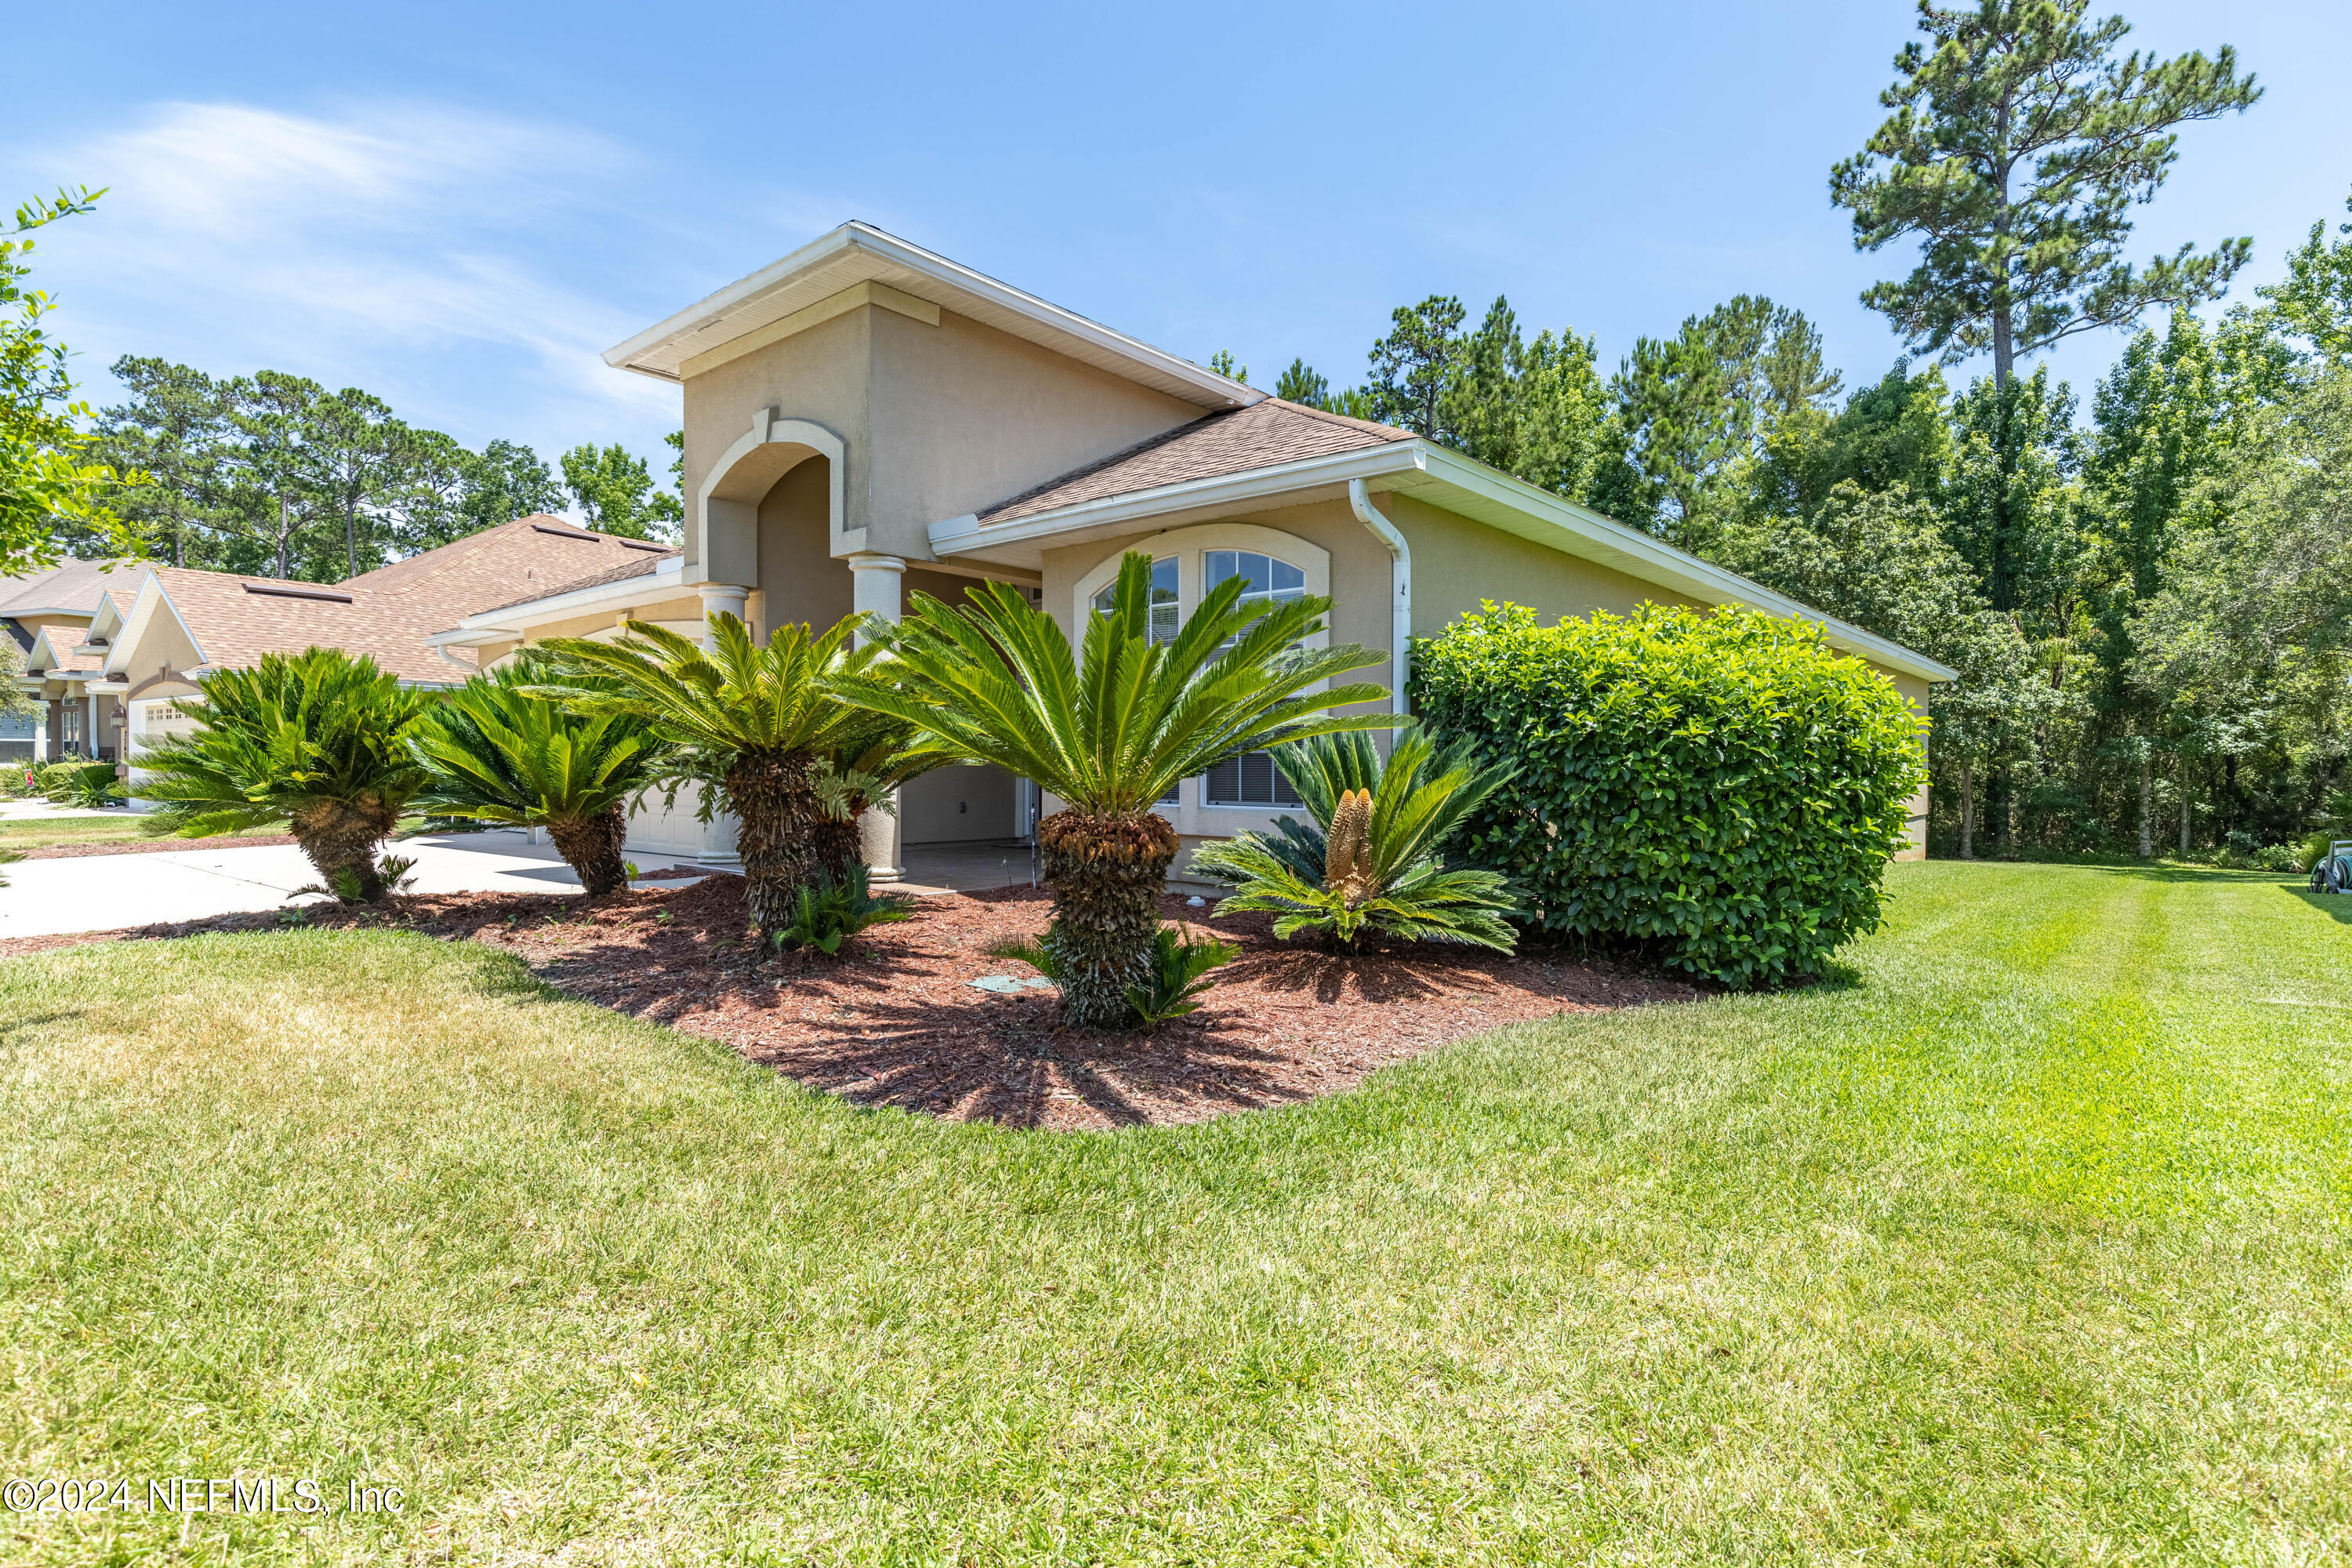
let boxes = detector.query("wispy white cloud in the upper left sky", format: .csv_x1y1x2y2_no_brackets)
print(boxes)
0,103,677,452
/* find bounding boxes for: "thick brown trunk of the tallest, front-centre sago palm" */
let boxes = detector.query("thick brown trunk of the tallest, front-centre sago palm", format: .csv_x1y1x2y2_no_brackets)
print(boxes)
1037,811,1178,1027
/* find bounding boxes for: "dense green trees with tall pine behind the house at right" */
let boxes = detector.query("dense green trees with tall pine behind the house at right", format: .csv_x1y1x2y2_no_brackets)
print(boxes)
1221,0,2352,855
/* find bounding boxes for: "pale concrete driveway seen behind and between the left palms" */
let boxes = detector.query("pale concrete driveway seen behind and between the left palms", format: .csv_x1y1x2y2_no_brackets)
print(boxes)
0,829,706,938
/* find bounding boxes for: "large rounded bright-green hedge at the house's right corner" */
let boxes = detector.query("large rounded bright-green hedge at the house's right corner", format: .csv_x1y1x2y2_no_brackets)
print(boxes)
1414,602,1924,987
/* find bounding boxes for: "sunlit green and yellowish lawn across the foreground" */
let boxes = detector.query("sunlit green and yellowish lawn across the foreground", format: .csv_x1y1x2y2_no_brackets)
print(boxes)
0,862,2352,1566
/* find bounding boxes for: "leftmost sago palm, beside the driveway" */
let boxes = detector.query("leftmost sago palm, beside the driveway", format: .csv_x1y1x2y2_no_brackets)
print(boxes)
139,649,435,902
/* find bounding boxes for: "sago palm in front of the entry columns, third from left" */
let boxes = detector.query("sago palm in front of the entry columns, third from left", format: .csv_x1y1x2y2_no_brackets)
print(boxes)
541,614,920,942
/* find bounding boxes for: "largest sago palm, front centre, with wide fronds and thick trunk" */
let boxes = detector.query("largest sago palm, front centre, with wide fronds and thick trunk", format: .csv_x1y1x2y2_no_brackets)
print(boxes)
844,555,1395,1025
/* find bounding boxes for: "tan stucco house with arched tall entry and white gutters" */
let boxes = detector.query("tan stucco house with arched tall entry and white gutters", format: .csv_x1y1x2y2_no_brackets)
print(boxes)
433,223,1952,879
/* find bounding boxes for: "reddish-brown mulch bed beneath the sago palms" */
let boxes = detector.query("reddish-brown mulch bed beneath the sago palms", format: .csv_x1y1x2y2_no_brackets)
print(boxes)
0,874,1700,1128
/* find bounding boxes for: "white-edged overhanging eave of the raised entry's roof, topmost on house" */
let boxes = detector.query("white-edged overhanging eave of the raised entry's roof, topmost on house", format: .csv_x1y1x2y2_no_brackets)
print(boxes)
604,223,1265,409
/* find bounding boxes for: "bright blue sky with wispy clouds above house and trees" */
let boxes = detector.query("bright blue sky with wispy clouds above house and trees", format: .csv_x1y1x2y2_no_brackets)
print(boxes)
0,0,2352,491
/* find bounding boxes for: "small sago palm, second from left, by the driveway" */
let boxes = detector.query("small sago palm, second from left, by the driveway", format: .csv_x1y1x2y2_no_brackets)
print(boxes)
409,659,670,898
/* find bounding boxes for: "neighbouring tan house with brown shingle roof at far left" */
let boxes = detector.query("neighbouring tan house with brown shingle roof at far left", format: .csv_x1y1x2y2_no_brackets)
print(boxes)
26,515,675,794
